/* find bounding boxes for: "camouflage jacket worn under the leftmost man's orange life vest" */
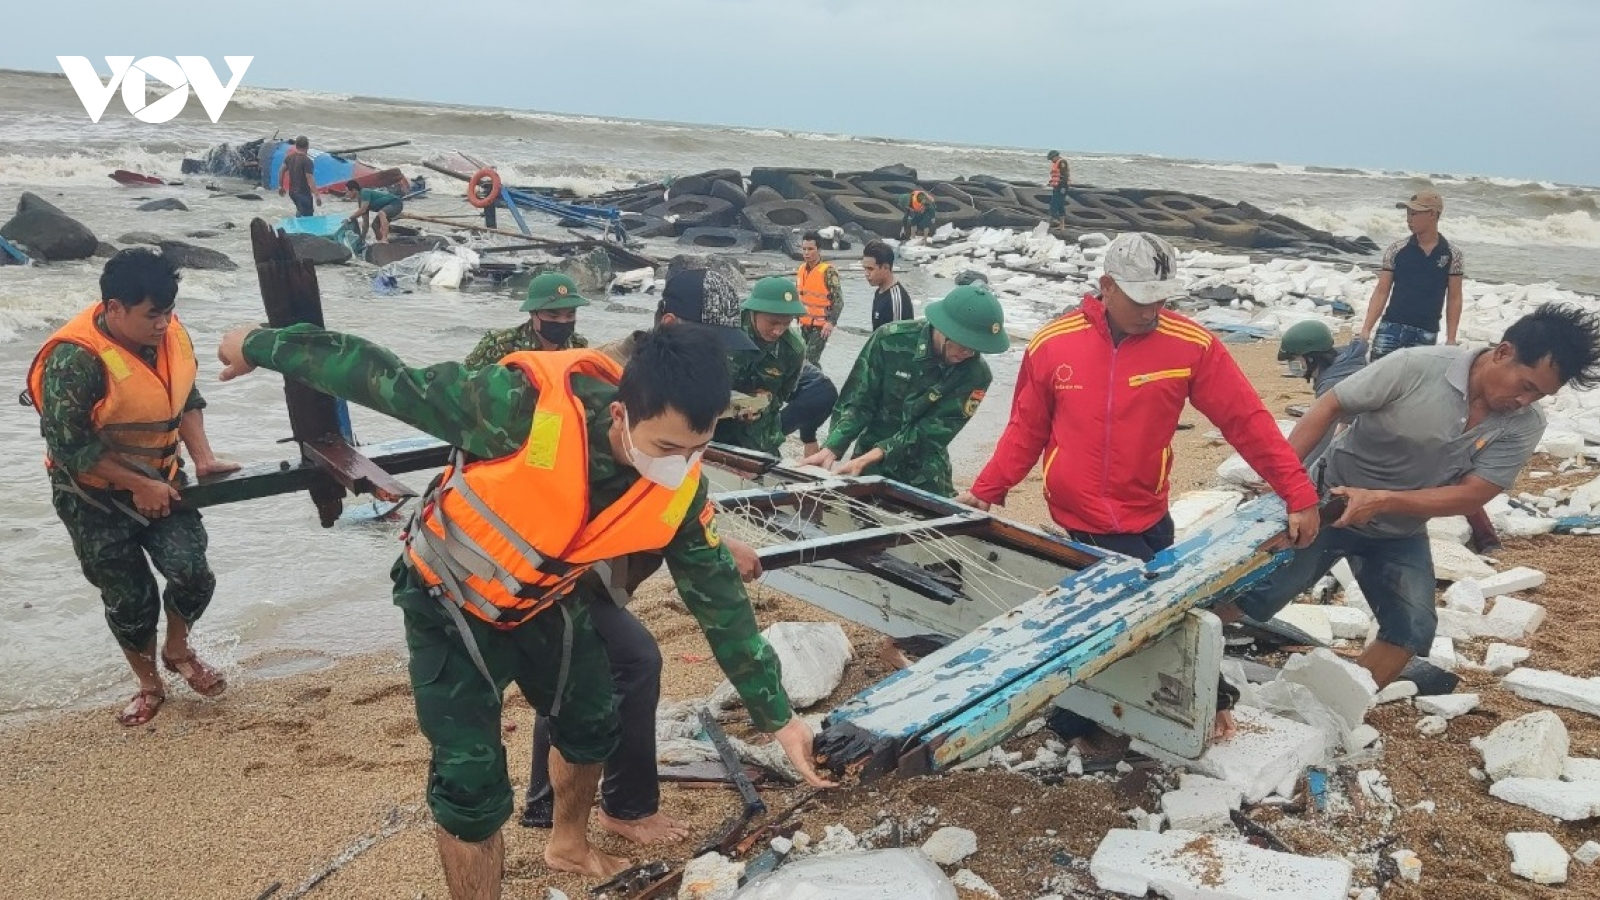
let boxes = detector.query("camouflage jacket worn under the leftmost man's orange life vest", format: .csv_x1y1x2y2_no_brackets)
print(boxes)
38,334,205,479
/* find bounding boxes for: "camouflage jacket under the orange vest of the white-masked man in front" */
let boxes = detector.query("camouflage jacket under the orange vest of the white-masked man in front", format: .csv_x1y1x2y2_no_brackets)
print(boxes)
245,325,792,732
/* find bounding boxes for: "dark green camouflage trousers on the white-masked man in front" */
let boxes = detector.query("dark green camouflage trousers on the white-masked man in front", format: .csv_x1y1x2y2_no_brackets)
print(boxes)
390,557,619,842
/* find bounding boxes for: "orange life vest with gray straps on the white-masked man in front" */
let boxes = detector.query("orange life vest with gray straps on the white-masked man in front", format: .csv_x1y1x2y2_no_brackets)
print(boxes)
406,349,699,629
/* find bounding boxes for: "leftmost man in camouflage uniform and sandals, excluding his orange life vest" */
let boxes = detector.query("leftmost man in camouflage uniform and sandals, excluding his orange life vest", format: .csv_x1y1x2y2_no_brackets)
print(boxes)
30,248,238,725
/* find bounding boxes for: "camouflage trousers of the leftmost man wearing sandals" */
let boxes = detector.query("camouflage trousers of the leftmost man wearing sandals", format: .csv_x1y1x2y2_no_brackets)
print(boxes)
53,480,216,653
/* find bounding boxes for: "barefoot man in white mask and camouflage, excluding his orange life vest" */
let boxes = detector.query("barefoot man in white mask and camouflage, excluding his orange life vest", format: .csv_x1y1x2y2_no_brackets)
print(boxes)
218,317,826,900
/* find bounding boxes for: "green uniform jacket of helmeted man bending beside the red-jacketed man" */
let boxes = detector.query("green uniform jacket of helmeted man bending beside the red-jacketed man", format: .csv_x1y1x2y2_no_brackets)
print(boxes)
824,320,992,496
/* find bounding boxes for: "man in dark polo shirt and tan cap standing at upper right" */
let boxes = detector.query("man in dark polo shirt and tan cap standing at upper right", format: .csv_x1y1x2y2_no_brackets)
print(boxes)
1360,191,1464,362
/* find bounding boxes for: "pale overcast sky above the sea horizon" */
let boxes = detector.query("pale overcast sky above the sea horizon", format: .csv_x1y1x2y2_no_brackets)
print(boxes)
0,0,1600,184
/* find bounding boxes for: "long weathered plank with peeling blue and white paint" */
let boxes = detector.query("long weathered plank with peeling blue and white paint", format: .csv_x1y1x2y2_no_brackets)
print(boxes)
824,498,1283,770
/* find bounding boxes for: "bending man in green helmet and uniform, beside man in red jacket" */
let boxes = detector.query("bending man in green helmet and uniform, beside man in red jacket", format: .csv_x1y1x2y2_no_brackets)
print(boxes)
802,285,1011,496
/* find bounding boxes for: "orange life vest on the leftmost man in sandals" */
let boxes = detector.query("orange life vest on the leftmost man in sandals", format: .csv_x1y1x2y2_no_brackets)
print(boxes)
27,303,198,488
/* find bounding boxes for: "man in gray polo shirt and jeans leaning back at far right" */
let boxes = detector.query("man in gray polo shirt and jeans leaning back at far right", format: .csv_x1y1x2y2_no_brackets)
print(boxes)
1216,303,1600,687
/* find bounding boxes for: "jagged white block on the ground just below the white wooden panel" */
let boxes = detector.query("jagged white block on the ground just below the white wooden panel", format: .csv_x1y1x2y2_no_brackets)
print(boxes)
1131,706,1323,802
